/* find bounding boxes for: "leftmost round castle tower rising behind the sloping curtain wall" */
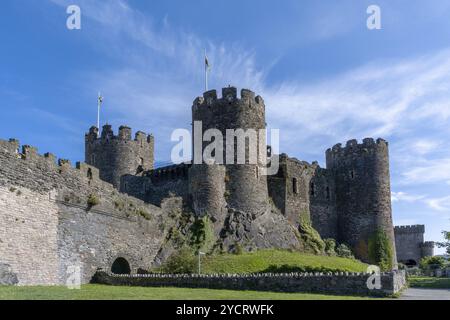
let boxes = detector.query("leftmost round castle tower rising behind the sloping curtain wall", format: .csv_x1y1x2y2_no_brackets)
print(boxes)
85,125,154,188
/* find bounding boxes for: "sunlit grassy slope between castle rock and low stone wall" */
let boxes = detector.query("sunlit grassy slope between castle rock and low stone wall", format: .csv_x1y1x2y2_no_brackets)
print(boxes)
202,250,367,274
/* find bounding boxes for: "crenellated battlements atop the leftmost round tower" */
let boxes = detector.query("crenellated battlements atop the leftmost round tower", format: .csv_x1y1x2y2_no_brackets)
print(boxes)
86,124,154,144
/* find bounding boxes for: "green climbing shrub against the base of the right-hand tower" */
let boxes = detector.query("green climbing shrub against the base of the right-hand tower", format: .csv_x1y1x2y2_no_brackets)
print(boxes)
368,229,394,271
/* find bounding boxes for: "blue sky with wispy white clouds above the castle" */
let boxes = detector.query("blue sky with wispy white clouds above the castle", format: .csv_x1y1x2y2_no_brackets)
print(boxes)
0,0,450,250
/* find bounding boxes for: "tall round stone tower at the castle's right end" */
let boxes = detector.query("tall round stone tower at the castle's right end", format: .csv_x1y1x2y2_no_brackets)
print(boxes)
326,138,397,266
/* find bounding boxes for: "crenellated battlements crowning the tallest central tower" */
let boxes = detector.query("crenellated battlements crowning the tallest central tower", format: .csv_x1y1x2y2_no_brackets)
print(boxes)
194,87,264,106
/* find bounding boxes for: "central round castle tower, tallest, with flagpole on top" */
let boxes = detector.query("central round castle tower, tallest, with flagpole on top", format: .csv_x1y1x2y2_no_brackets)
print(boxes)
190,87,268,219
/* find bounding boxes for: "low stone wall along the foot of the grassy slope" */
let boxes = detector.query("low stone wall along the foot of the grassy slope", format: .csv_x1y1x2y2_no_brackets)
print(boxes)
93,271,406,297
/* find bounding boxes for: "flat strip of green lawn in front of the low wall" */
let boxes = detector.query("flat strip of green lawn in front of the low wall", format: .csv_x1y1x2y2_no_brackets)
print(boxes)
0,285,370,300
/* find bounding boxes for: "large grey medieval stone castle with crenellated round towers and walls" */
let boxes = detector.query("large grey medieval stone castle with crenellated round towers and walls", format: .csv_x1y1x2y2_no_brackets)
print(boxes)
0,87,430,285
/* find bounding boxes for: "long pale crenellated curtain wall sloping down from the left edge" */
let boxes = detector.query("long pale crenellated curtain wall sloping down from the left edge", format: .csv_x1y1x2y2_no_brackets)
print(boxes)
0,141,170,285
